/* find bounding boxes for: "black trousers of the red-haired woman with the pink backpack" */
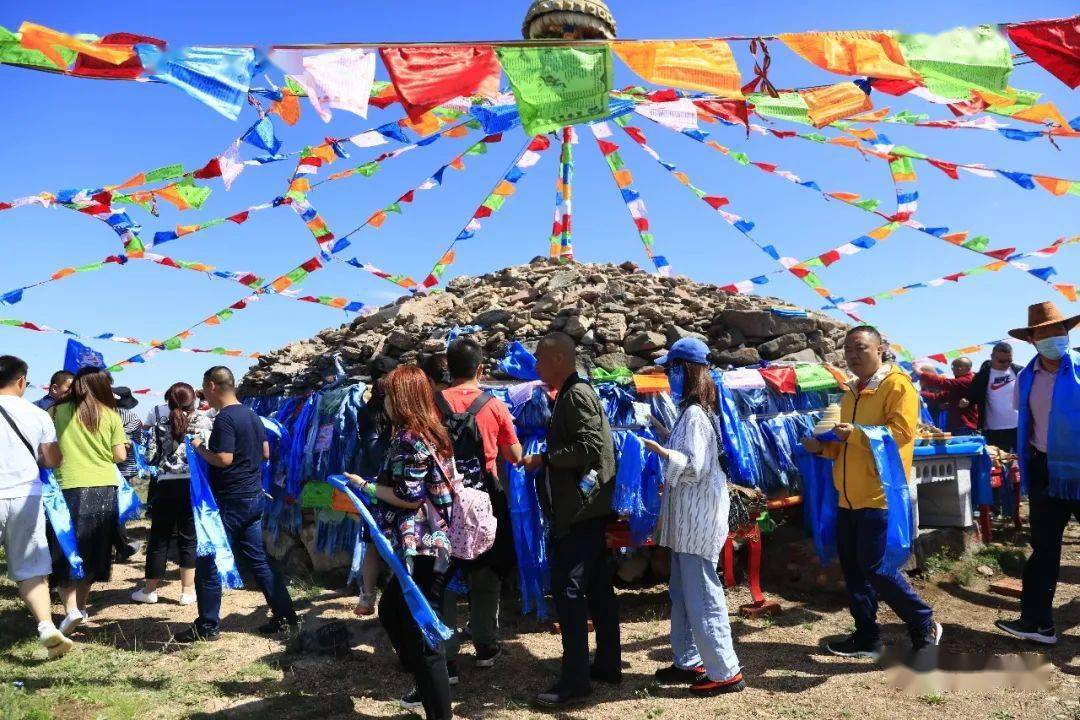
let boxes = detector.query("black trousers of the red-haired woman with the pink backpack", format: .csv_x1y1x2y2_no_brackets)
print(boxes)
379,555,454,720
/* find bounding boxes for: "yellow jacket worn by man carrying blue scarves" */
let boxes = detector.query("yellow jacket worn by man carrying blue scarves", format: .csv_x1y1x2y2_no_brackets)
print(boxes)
821,364,919,510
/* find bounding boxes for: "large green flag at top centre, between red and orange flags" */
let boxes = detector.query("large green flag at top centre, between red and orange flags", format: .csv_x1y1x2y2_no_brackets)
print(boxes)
497,45,613,135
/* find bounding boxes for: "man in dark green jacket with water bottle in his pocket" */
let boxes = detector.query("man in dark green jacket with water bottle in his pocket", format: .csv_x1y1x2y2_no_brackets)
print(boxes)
523,332,622,708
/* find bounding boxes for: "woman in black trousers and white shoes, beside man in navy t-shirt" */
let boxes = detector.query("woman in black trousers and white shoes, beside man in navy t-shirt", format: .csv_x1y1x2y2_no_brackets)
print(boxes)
132,382,214,604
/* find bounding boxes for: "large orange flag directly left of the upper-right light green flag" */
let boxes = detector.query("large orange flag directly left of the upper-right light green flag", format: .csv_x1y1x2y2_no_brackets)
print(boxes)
780,31,919,80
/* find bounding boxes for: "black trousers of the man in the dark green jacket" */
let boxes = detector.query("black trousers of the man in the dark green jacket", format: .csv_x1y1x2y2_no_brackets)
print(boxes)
551,517,622,693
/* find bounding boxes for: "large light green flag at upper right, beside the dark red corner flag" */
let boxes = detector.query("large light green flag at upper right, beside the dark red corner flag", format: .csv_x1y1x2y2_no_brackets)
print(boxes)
896,25,1012,100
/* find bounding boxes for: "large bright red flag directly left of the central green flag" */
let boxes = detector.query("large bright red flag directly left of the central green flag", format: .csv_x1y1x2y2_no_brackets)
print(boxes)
379,45,501,120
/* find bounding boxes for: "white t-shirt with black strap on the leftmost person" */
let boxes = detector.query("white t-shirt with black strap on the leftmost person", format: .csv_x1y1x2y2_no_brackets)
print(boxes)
0,395,56,499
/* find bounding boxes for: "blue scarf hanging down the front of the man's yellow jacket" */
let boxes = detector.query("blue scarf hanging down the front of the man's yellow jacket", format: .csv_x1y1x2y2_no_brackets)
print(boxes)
856,425,915,574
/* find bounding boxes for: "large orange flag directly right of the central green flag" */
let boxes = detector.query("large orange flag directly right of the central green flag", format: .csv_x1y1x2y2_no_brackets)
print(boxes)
611,40,743,100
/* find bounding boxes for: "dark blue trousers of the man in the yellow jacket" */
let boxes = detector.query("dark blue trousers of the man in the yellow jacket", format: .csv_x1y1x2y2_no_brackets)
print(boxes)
836,507,933,642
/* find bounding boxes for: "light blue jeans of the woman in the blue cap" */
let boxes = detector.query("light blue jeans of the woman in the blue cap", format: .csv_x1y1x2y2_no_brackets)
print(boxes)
669,552,739,682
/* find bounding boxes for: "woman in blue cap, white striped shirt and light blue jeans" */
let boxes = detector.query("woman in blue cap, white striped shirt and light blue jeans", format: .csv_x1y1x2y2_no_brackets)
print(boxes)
645,338,746,696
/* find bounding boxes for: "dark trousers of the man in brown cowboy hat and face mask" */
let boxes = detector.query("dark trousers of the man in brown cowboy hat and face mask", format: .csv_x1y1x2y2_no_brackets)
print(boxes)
1020,448,1080,629
